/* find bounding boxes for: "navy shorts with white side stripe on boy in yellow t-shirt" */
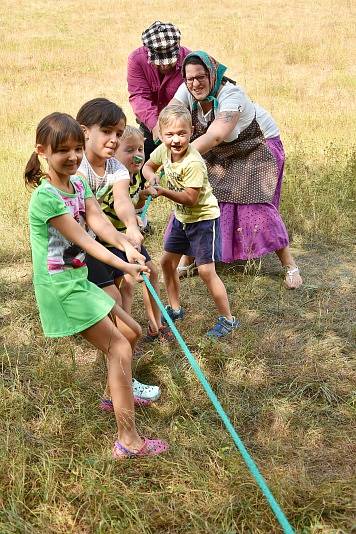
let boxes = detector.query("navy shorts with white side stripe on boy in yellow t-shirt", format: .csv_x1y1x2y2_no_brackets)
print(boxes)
164,217,221,266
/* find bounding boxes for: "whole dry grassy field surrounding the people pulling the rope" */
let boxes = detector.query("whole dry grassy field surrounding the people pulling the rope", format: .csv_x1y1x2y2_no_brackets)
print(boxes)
0,0,356,534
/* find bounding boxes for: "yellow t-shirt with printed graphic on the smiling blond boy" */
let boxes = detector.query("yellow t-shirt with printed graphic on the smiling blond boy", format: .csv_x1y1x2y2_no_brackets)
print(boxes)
150,143,220,223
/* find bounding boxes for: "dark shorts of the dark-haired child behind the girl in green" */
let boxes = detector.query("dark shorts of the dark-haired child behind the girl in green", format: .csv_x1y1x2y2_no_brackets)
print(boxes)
85,245,151,287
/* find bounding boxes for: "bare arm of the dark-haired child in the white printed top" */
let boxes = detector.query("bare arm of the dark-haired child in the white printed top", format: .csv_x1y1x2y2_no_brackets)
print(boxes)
113,180,143,247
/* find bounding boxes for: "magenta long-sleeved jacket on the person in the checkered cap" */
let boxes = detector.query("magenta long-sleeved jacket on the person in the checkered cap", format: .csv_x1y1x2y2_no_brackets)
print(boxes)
127,46,190,130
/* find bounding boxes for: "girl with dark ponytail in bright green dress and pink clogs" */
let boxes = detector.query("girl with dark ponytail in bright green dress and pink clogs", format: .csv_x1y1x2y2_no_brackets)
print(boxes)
25,113,168,458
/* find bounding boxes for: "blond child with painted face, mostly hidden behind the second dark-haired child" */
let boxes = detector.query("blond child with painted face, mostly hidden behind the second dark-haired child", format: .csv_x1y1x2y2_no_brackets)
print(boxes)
115,126,173,341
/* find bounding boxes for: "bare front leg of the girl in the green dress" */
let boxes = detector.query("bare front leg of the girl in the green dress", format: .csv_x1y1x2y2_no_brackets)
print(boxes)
81,317,143,451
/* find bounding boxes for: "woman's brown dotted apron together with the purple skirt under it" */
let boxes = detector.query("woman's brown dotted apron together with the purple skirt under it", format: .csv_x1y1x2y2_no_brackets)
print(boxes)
192,112,289,263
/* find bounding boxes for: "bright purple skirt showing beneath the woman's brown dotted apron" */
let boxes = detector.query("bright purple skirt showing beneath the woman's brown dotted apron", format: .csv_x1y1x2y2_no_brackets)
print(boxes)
219,136,289,263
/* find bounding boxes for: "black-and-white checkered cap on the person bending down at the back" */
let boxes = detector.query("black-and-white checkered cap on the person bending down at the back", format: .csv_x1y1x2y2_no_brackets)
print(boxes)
141,20,180,65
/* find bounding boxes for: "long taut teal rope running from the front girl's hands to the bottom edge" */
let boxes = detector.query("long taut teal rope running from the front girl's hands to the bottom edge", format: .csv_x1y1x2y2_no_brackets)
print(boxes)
142,273,294,534
